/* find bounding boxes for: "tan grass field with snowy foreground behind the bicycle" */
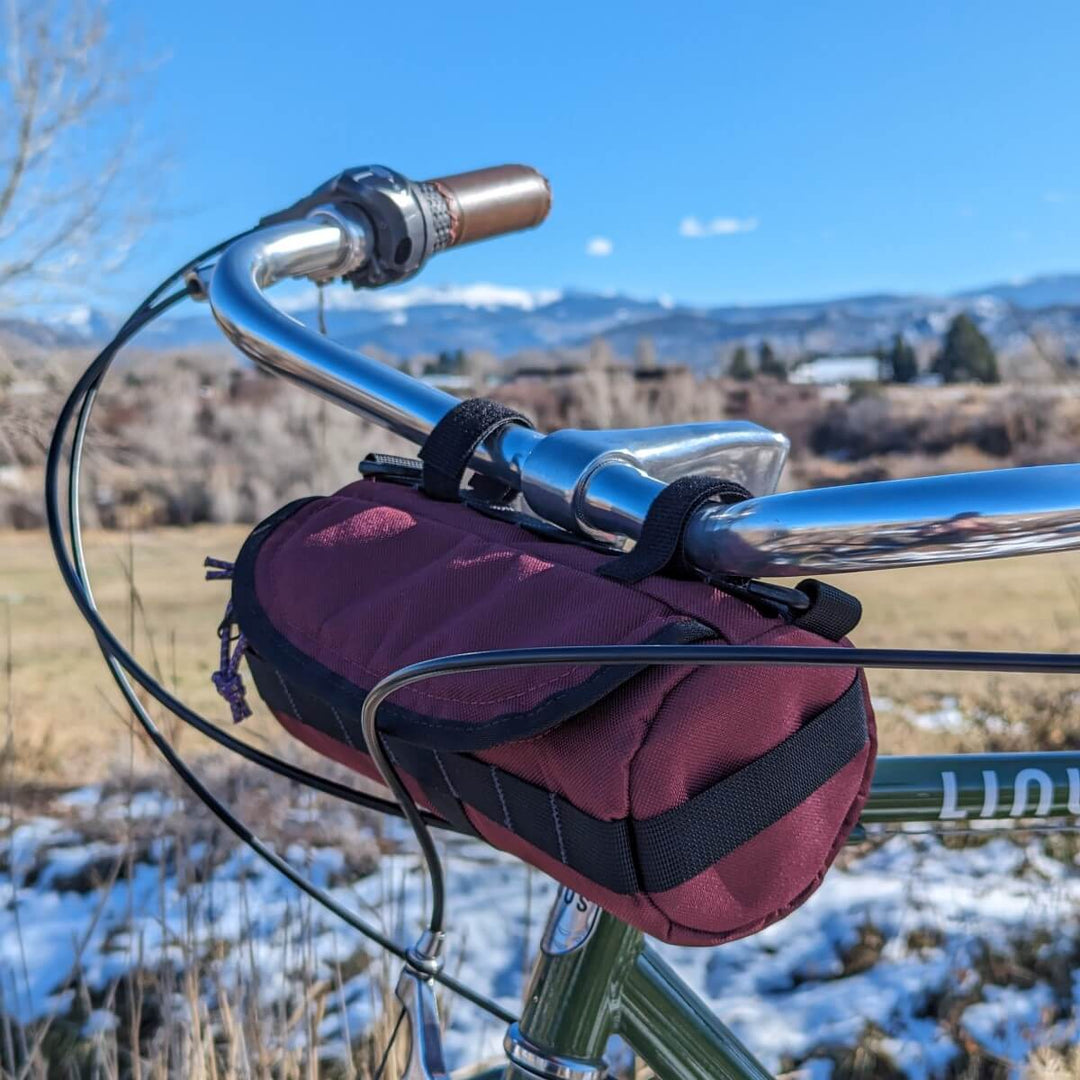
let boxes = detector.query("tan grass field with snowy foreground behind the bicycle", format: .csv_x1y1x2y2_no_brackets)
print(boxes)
6,526,1080,1080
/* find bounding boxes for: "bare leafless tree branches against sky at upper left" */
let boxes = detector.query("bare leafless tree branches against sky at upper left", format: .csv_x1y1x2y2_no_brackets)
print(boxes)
0,0,146,308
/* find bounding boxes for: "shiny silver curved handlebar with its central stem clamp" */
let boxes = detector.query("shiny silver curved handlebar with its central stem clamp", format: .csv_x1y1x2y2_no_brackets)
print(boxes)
203,210,1080,577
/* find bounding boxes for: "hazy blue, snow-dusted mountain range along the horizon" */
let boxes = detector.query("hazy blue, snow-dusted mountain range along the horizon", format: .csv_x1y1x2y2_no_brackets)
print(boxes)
6,274,1080,367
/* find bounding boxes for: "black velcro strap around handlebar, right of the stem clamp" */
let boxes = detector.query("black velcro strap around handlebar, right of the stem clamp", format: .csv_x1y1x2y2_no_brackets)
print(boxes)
596,474,751,584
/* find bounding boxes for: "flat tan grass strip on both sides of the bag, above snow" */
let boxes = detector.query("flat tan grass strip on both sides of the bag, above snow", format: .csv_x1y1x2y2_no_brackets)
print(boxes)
0,526,1080,783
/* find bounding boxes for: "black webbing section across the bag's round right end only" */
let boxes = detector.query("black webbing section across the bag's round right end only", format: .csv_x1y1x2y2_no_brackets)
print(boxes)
632,675,867,892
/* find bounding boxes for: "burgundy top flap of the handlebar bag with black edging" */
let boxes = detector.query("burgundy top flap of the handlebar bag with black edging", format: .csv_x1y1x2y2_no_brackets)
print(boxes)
233,481,818,750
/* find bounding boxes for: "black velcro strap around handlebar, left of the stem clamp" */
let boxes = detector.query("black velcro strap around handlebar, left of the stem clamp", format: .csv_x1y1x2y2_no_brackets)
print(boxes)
420,397,532,502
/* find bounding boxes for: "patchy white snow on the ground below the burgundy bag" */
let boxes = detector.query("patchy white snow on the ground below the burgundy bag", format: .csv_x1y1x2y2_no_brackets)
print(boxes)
0,788,1080,1078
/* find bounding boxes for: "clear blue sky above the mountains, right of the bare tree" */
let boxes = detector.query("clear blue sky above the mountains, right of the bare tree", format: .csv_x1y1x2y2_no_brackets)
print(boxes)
110,0,1080,303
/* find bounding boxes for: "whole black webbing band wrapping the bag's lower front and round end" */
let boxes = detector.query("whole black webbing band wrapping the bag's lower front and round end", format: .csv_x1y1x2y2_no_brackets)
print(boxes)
247,653,867,895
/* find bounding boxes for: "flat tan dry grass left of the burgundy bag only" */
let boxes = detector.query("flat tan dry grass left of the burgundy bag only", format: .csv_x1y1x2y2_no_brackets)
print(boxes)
0,526,298,783
